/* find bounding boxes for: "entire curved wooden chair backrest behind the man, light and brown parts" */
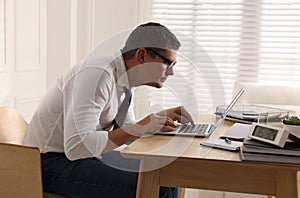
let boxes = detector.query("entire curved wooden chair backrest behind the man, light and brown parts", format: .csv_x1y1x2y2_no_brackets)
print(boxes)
0,107,43,198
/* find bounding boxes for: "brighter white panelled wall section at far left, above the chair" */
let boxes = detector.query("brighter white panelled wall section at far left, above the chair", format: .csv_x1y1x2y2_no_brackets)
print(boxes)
0,0,46,121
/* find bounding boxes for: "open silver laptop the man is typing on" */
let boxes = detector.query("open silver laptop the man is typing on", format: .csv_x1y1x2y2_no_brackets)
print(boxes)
155,88,245,137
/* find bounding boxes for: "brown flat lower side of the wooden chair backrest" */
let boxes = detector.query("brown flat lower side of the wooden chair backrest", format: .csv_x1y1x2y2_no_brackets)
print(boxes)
0,143,43,198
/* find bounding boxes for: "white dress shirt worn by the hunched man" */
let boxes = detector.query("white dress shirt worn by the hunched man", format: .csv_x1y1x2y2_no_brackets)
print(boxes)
23,54,135,160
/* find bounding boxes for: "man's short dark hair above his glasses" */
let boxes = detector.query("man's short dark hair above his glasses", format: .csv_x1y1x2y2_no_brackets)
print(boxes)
122,22,181,58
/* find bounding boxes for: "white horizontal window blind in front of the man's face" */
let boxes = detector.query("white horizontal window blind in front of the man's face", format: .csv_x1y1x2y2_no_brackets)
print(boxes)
148,0,300,112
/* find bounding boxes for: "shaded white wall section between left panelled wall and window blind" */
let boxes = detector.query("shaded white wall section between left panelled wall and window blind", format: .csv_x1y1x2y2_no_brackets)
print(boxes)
47,0,138,86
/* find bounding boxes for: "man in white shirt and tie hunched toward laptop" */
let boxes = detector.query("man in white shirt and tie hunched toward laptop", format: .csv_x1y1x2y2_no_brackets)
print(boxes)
23,23,193,197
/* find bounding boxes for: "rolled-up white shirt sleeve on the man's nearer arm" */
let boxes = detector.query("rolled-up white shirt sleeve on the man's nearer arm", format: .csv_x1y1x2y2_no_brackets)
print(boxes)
63,67,114,160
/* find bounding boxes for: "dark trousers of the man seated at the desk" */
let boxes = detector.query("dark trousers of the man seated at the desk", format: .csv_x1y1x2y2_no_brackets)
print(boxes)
42,151,178,198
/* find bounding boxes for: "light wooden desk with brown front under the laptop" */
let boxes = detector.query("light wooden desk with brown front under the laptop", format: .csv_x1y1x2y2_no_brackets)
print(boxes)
121,117,300,198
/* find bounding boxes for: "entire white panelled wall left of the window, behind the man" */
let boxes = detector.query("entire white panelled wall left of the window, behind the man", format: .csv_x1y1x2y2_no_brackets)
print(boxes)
0,0,138,121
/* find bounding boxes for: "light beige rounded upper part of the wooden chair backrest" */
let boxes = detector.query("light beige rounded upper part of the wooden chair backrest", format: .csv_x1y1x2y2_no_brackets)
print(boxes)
0,107,28,144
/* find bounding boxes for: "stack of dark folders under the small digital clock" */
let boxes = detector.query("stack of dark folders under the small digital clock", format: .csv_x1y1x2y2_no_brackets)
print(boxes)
240,139,300,164
